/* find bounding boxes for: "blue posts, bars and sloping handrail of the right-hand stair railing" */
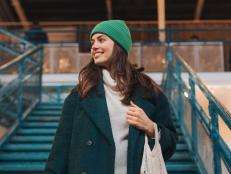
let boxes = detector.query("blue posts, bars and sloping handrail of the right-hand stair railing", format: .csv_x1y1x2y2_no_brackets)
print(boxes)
166,44,231,174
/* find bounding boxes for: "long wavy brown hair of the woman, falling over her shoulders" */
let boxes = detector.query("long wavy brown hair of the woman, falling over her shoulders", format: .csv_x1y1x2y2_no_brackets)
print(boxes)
77,43,160,105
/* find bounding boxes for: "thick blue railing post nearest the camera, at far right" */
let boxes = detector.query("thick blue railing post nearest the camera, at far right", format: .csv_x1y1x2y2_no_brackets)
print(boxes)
209,101,221,174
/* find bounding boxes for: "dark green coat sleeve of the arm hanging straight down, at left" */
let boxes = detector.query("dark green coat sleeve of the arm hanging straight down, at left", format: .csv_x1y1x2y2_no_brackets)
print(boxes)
45,92,78,174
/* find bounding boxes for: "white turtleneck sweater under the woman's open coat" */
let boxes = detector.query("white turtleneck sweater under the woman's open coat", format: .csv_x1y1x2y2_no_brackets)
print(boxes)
103,69,129,174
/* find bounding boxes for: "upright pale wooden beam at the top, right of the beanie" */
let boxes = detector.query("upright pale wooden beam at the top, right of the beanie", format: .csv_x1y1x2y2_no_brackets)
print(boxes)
157,0,166,42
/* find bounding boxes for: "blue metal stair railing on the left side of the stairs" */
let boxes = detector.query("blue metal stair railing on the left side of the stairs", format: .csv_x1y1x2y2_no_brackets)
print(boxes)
0,46,43,146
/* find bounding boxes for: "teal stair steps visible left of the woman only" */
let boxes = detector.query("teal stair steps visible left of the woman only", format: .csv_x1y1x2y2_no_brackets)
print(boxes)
0,103,62,174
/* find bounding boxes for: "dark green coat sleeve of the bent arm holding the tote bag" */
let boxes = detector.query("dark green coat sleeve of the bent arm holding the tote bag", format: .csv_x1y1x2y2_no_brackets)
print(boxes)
149,92,177,160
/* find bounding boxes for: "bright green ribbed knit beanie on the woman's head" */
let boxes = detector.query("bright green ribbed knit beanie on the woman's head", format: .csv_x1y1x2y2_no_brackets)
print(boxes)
90,20,132,53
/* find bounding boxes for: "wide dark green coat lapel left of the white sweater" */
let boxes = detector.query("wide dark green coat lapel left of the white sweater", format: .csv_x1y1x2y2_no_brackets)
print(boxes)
81,80,114,144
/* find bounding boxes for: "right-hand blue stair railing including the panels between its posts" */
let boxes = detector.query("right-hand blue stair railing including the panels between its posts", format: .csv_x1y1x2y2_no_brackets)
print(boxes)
165,46,231,174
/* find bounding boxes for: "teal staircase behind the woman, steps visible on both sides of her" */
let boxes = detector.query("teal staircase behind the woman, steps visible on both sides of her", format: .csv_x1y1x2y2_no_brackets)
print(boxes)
0,103,197,174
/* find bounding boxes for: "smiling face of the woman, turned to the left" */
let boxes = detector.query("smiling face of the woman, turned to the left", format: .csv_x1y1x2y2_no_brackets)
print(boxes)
91,33,114,67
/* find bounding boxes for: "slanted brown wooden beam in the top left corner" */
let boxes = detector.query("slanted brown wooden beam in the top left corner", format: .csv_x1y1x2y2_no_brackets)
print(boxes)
11,0,29,29
